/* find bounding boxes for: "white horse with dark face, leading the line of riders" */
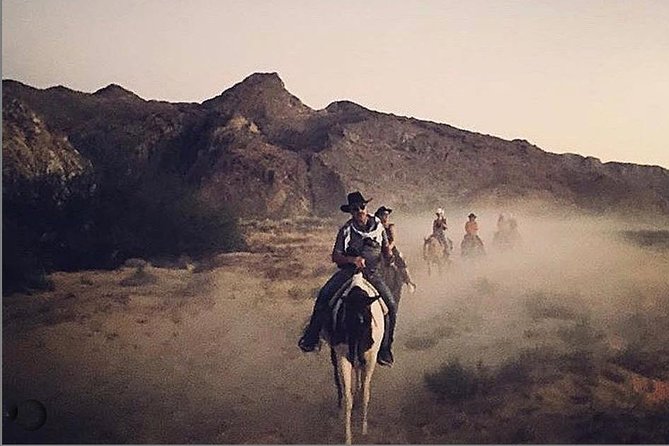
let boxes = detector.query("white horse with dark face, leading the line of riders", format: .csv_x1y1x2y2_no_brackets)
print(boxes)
328,273,388,444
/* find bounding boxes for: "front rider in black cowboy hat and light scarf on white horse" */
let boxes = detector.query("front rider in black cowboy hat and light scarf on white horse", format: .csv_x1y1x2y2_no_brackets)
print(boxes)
298,191,397,366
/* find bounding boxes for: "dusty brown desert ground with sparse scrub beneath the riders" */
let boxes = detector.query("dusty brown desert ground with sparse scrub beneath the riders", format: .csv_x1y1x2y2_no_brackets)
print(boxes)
2,209,669,444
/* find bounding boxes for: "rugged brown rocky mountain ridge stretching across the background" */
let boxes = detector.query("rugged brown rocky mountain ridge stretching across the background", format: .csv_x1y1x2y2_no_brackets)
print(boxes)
3,73,669,217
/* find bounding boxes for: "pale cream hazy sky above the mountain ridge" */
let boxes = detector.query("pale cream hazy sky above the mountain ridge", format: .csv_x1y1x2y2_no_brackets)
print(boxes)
2,0,669,168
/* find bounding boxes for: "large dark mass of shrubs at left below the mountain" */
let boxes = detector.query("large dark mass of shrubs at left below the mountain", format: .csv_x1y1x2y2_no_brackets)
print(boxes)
3,169,245,293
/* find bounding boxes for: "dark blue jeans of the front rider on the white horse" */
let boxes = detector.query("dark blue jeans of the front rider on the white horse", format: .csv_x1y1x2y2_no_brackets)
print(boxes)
304,268,397,350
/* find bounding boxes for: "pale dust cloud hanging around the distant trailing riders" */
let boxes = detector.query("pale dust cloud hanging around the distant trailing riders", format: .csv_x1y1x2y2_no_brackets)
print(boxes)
394,209,669,359
